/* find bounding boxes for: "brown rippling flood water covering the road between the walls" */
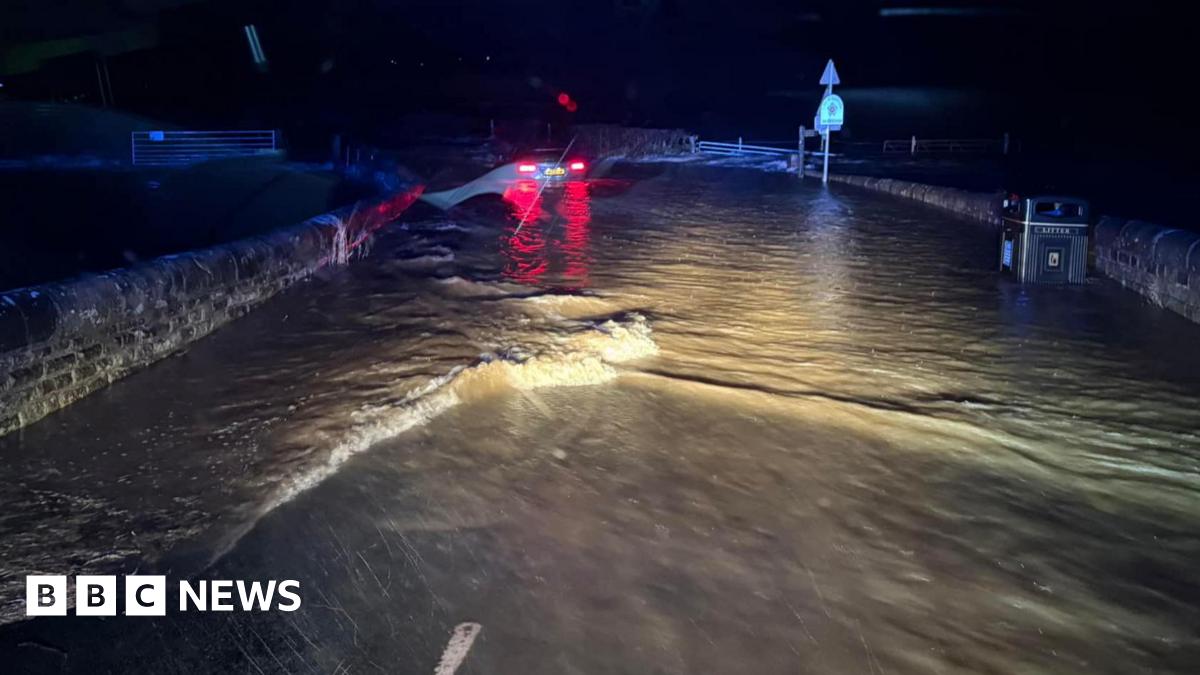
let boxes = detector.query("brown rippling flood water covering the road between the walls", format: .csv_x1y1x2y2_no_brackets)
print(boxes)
0,159,1200,675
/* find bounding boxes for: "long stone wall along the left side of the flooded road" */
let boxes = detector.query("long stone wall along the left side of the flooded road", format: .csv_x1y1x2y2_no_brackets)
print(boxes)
0,187,420,435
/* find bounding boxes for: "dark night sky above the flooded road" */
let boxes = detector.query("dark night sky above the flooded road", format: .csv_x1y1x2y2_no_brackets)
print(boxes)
0,0,1194,157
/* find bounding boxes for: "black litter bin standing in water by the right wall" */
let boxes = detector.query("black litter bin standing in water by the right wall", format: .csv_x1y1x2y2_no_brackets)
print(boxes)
1000,196,1088,283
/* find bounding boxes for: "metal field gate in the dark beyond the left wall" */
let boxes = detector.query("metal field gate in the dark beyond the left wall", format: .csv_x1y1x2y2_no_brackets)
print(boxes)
130,130,278,166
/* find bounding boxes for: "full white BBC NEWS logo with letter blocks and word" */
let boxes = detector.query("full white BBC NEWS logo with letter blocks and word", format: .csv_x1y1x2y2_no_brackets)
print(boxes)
25,574,300,616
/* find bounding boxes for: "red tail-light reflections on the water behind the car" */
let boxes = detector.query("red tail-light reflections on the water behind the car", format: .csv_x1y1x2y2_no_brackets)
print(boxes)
500,180,592,288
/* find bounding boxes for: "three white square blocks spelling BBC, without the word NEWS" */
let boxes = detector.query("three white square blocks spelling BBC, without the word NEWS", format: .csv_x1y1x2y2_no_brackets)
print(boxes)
25,574,167,616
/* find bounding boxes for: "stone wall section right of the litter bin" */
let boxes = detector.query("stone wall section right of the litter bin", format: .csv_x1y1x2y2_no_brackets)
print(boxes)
1093,216,1200,322
